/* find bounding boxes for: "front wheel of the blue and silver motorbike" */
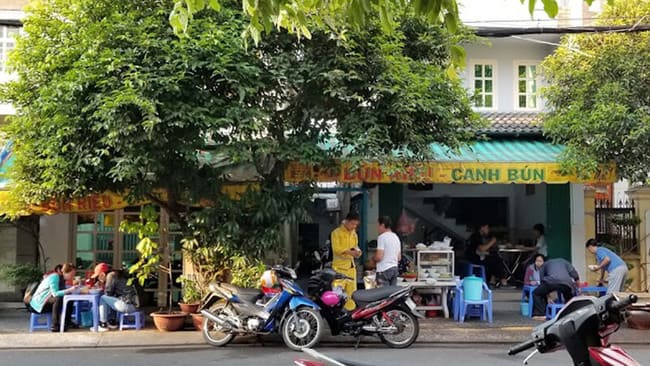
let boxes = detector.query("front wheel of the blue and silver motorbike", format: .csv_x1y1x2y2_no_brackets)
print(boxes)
280,307,325,351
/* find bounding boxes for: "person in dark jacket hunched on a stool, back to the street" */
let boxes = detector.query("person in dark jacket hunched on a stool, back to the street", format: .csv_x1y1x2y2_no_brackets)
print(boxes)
533,258,579,319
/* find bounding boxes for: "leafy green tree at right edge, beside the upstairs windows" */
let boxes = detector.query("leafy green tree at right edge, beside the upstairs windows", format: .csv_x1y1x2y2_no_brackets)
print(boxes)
542,0,650,182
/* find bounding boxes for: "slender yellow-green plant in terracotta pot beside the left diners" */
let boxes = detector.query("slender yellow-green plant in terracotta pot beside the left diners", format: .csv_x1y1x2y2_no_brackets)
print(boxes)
120,205,187,331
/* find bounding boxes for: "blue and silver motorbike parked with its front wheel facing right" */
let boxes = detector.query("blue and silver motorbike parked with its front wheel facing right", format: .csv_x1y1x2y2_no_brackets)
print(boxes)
201,266,324,350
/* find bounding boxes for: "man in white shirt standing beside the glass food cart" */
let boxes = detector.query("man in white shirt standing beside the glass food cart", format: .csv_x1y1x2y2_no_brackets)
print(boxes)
373,216,402,287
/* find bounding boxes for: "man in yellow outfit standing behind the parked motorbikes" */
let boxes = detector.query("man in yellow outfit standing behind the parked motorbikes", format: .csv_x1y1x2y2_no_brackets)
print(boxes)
331,212,361,310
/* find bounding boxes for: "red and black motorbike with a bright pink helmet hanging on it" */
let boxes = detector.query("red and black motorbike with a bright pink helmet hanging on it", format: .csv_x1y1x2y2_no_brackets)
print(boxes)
307,268,422,348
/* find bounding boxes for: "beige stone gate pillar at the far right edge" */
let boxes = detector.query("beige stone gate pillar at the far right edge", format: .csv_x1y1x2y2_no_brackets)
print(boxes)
626,186,650,291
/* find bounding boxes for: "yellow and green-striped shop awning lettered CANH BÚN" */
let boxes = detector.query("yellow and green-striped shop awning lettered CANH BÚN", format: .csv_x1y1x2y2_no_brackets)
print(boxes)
285,139,616,184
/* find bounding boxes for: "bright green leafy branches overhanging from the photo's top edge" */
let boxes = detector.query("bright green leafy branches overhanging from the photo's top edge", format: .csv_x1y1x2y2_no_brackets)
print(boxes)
169,0,613,42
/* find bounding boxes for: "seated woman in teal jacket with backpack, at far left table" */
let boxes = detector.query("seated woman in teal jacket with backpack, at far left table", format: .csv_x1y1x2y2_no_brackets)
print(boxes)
29,263,77,332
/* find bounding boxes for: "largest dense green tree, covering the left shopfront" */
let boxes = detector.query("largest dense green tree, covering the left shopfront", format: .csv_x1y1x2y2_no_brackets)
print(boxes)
3,0,476,284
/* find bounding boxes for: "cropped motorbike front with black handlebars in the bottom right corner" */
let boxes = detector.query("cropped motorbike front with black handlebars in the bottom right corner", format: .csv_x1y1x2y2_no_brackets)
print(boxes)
508,294,640,366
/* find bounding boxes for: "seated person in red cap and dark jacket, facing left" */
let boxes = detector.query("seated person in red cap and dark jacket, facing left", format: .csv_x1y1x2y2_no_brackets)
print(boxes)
99,269,140,332
